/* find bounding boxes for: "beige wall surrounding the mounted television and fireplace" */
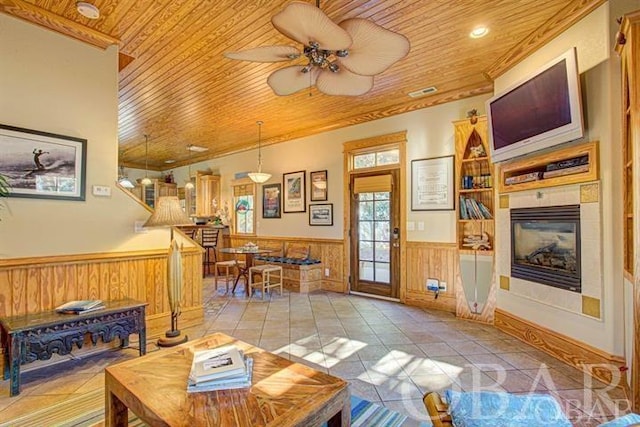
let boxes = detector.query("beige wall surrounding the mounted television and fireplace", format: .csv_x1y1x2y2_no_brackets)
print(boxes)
495,3,624,355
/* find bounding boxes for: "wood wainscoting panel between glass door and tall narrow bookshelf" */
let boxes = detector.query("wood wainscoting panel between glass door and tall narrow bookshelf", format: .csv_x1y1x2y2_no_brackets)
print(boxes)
408,242,458,313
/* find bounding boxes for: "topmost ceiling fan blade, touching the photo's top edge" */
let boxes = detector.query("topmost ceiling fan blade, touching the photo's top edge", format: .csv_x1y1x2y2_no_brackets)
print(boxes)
271,1,351,50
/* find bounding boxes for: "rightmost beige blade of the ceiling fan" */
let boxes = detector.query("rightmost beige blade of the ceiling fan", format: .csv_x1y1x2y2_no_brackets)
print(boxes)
339,18,411,76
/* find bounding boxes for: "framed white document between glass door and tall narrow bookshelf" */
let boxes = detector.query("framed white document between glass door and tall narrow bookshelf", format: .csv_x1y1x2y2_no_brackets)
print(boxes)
411,156,455,211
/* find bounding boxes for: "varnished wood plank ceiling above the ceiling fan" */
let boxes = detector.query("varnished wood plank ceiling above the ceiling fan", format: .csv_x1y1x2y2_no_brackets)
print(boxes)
0,0,604,170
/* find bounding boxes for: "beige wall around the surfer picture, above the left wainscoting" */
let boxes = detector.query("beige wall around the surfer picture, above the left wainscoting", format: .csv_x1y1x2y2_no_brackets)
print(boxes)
0,14,168,258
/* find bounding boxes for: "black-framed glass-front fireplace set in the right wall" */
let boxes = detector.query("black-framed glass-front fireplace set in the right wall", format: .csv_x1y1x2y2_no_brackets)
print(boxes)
511,205,581,292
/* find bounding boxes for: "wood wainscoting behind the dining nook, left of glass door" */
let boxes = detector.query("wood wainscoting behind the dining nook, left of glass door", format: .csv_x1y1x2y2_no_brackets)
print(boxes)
230,234,349,293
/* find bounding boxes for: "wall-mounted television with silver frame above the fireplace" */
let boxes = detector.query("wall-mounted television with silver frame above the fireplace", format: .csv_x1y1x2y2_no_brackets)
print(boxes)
486,48,584,162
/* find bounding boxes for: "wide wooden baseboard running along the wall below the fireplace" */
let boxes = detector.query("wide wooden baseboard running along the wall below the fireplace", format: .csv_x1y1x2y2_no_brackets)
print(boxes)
495,308,629,391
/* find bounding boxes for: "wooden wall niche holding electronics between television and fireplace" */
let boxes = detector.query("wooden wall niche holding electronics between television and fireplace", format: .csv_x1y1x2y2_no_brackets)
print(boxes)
498,141,598,193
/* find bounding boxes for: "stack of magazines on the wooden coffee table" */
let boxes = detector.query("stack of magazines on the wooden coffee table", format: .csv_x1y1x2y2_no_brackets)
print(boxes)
187,345,253,393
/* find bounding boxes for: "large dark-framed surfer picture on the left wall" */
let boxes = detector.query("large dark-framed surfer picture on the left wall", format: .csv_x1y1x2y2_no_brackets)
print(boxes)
0,125,87,200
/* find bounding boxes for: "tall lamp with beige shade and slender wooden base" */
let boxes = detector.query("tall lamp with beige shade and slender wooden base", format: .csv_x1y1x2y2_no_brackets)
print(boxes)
143,196,192,347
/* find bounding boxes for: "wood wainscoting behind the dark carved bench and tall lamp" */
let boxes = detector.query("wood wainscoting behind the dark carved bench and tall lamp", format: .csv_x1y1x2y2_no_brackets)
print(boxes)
0,247,204,337
